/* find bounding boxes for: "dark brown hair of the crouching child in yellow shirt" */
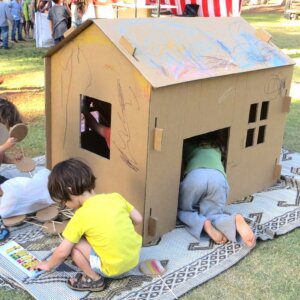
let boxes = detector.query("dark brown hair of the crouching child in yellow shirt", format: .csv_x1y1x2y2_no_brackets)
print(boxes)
48,158,96,202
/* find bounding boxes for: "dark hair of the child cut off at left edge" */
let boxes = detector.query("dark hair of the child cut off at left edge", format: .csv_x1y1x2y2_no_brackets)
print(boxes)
0,98,22,127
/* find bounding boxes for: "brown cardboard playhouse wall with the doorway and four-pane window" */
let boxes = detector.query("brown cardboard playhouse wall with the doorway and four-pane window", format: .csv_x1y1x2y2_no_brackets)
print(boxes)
145,67,292,244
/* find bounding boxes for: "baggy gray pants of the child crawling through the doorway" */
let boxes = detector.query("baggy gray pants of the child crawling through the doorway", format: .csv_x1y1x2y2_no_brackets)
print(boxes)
178,168,236,242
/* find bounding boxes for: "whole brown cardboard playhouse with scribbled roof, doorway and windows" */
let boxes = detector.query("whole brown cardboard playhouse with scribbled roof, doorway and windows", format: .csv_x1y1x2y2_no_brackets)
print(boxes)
45,17,293,244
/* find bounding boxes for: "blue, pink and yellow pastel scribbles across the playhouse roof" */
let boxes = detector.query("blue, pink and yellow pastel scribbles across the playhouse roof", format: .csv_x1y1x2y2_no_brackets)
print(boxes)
108,19,288,80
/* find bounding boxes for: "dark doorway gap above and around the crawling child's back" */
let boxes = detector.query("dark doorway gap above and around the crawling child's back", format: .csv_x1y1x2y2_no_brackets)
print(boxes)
181,128,230,178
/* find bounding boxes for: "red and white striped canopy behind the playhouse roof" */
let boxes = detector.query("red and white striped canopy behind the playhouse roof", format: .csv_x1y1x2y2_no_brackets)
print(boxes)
161,0,242,17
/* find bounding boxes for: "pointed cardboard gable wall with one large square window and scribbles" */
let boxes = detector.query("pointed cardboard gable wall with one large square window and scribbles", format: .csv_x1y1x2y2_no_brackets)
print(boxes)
47,25,150,231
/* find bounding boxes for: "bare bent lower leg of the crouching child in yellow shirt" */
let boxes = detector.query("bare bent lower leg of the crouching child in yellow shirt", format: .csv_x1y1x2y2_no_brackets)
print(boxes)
71,238,100,280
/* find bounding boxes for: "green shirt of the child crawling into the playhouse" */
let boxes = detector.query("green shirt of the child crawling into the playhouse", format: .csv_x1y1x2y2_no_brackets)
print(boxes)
183,143,226,177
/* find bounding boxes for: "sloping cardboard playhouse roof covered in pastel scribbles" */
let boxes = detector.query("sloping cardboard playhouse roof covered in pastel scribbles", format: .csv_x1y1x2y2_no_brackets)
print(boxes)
46,17,294,88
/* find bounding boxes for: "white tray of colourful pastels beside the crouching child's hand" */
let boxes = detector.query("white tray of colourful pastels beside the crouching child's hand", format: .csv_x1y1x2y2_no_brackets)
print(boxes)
0,241,44,278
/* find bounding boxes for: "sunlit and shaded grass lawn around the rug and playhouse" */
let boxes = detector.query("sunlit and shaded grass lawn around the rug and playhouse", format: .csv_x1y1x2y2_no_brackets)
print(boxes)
0,10,300,300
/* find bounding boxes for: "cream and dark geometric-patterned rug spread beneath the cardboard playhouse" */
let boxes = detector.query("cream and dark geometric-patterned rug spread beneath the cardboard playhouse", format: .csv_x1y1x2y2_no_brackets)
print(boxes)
0,150,300,300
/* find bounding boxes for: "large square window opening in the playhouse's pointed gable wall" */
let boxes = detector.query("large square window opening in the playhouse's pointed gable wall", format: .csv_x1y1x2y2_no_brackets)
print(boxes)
80,95,111,159
